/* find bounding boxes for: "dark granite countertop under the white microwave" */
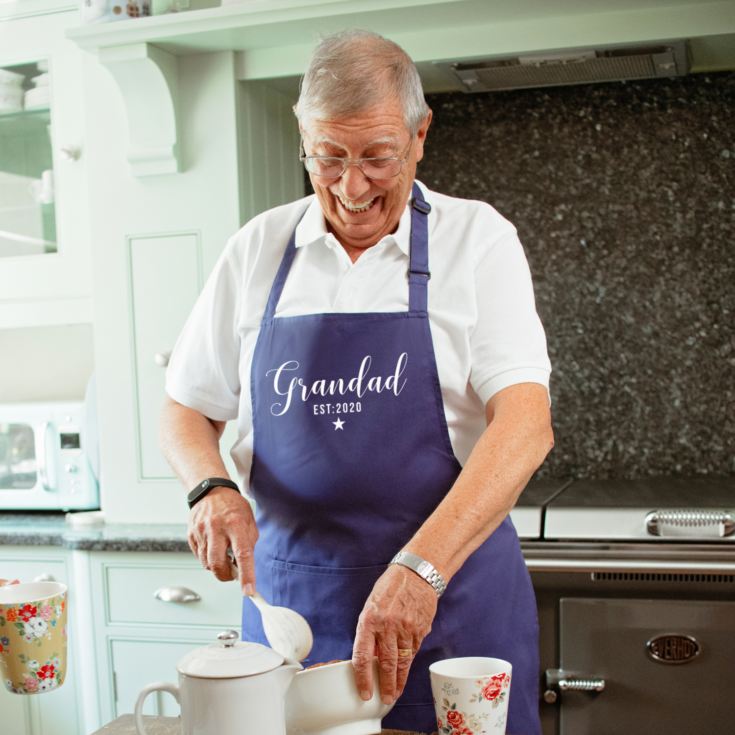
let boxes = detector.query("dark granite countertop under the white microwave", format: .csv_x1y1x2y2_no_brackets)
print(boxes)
0,511,189,552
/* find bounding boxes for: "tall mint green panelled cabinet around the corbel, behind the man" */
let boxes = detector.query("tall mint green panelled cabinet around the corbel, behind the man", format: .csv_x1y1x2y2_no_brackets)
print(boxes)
85,38,303,523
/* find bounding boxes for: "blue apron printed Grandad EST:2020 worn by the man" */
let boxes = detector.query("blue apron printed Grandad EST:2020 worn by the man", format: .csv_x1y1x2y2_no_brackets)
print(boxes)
242,184,541,735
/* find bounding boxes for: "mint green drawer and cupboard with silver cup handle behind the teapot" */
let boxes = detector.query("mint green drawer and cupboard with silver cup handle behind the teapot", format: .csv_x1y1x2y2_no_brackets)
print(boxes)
89,552,242,723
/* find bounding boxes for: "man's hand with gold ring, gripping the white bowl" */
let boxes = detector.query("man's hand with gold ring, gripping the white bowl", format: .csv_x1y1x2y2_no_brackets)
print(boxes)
352,565,437,704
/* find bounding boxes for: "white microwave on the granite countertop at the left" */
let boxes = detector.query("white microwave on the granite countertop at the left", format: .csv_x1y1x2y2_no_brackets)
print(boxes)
0,402,99,510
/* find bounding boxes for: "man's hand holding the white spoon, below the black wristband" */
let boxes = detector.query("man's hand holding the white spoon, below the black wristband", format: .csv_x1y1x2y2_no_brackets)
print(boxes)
188,487,258,595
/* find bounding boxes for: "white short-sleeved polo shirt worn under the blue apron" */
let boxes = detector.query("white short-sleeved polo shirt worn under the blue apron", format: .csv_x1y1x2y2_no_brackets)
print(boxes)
166,182,551,480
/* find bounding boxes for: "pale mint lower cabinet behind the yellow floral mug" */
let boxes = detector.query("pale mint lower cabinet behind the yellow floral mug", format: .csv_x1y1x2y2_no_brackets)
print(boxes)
0,546,85,735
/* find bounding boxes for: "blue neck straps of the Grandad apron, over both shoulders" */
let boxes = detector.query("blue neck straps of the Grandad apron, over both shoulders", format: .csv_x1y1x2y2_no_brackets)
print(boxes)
263,182,431,320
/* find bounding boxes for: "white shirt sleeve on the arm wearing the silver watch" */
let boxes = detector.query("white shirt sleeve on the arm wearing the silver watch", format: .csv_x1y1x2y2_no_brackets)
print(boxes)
470,229,551,404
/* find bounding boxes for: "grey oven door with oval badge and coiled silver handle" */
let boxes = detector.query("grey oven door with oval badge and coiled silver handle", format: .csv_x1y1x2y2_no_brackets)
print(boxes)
546,598,735,735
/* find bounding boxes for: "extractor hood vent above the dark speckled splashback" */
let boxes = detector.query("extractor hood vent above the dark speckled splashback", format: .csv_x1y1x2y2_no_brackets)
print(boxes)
437,41,689,92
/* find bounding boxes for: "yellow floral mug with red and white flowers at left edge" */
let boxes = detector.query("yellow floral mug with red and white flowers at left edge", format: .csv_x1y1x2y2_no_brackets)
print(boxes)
0,582,67,694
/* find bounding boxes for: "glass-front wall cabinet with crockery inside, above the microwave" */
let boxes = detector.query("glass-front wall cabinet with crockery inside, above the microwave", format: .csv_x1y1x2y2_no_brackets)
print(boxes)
0,12,92,329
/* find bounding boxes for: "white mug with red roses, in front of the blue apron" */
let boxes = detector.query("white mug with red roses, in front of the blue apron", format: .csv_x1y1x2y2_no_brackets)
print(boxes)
429,656,513,735
